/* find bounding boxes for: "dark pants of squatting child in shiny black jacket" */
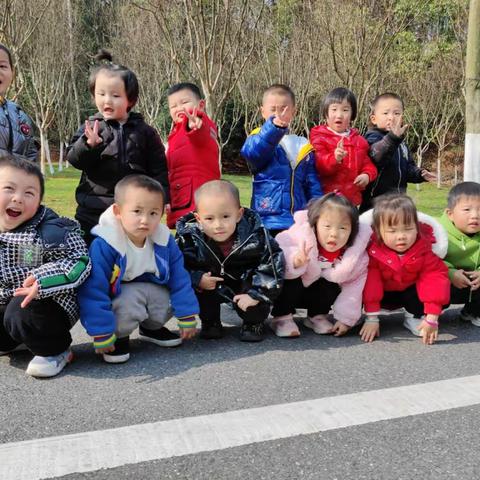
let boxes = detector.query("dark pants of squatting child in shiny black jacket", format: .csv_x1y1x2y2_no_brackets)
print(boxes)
196,290,270,325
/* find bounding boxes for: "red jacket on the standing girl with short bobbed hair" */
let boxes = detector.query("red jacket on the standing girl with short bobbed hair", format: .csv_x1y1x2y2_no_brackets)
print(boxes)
310,125,377,205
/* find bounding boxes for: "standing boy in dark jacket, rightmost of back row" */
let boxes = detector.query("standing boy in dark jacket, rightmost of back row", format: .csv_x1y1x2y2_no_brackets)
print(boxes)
360,93,436,212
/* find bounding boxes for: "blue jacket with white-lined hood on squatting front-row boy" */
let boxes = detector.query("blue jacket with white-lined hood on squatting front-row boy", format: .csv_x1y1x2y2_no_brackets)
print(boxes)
78,207,199,337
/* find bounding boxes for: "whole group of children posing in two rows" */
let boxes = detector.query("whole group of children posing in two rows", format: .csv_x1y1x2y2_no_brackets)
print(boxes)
0,45,480,377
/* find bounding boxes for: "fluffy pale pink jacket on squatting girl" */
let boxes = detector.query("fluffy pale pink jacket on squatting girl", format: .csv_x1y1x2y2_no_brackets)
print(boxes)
275,210,372,326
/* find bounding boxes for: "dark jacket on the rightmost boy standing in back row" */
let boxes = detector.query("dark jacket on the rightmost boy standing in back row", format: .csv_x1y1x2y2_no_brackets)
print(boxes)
360,127,425,212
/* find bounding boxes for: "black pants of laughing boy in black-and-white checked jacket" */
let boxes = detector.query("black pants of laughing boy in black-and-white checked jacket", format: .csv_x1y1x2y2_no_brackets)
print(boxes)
0,297,72,357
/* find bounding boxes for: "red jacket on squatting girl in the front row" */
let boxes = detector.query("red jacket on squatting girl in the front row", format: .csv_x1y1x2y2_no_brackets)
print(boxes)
363,223,450,315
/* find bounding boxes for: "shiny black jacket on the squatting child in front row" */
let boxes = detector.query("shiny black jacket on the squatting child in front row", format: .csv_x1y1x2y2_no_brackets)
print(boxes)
177,208,285,303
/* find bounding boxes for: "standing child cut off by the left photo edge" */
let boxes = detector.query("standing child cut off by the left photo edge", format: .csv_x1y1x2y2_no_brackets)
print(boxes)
0,43,37,161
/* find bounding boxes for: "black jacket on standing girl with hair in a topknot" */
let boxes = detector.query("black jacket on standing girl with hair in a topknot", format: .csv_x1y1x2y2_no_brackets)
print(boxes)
67,113,168,226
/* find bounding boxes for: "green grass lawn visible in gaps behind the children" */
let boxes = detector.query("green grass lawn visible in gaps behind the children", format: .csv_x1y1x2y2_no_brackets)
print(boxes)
44,167,450,217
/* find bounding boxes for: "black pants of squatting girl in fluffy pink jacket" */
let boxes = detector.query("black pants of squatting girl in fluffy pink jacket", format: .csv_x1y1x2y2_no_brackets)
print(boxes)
272,278,341,317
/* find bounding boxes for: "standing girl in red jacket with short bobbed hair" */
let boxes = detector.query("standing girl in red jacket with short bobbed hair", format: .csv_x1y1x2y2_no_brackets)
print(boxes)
310,88,377,206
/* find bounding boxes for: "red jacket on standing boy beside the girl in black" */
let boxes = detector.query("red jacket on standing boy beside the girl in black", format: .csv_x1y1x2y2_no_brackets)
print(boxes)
166,112,220,228
